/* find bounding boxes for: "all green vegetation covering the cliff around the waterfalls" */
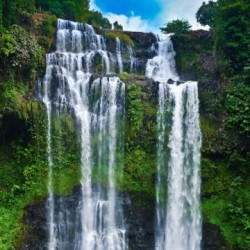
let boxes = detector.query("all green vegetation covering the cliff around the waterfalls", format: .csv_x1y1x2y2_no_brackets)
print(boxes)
0,0,250,250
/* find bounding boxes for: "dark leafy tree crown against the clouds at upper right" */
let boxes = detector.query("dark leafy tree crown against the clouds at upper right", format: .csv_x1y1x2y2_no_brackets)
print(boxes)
195,1,218,27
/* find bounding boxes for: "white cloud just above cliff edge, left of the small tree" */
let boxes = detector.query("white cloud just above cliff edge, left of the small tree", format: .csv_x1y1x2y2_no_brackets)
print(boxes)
104,13,153,32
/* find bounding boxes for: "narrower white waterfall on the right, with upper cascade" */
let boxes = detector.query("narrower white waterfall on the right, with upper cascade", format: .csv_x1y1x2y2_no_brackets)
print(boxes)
146,38,201,250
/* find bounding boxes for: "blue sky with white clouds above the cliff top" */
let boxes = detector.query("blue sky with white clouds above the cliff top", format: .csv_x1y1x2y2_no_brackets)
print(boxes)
90,0,204,33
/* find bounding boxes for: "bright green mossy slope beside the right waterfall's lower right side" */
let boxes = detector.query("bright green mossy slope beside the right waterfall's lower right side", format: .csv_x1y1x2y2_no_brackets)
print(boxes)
201,158,250,249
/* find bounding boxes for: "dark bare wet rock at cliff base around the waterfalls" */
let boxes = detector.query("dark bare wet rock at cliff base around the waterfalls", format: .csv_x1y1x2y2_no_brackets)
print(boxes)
21,187,223,250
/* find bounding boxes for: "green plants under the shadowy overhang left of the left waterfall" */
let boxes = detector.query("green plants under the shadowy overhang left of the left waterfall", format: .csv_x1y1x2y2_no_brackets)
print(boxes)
0,101,47,249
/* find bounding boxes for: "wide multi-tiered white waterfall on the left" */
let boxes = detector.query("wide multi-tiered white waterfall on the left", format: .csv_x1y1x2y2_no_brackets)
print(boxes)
40,19,127,250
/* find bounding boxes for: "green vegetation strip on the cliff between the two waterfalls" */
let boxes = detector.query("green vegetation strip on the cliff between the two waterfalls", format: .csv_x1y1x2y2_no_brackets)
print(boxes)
119,73,157,199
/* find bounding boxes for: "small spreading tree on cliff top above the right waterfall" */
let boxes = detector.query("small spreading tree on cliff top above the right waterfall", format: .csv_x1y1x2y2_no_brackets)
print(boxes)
160,19,191,36
